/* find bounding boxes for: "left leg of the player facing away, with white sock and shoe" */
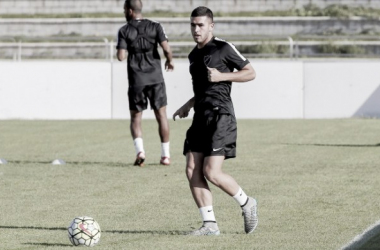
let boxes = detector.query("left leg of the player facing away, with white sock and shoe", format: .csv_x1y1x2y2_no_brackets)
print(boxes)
130,110,145,167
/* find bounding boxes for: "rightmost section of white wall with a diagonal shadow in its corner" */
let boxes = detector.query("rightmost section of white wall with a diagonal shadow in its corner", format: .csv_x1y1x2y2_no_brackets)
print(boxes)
304,60,380,118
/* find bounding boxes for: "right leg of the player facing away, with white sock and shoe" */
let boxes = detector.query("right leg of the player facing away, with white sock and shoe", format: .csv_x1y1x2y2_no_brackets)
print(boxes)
154,106,170,165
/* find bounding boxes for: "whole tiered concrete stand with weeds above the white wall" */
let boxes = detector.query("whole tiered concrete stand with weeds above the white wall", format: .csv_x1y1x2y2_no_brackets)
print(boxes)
0,0,380,60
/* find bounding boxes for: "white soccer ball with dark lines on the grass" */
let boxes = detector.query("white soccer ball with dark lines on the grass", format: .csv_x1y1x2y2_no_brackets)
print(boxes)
67,216,101,247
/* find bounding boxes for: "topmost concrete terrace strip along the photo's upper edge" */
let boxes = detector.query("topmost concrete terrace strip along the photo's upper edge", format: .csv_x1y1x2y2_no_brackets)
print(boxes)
0,0,380,14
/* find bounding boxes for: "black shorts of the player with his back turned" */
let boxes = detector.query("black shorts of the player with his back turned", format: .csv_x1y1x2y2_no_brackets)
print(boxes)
128,82,167,111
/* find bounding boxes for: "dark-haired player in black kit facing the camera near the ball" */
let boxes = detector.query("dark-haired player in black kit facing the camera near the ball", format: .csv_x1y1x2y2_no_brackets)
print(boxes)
173,6,258,235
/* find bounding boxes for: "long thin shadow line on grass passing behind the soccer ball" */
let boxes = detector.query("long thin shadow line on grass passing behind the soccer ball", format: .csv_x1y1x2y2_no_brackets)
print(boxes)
0,226,187,235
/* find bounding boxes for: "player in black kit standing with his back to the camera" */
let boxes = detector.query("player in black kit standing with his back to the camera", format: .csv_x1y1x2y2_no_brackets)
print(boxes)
116,0,174,167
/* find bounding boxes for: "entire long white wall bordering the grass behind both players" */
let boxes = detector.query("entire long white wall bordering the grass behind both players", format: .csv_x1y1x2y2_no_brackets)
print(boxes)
0,59,380,119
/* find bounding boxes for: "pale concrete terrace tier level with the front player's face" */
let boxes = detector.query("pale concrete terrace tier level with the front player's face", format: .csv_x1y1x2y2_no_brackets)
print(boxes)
0,16,380,39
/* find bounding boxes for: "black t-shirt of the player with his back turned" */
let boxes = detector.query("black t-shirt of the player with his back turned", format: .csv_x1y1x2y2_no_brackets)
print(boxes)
116,19,167,86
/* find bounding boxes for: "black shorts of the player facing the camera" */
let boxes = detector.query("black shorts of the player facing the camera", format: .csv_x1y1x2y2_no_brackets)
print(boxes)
183,111,237,159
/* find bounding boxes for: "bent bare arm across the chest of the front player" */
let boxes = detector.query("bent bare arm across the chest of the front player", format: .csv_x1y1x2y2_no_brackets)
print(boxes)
207,63,256,82
